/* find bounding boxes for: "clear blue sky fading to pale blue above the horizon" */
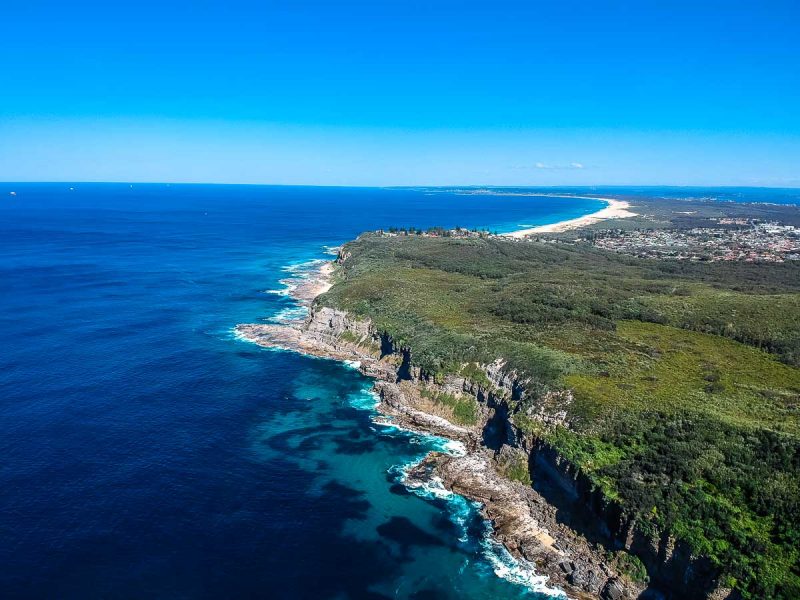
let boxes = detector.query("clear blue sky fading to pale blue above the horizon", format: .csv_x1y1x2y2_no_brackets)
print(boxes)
0,0,800,187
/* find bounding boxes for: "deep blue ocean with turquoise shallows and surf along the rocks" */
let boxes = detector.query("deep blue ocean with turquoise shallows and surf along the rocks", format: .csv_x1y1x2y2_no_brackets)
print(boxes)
0,184,796,598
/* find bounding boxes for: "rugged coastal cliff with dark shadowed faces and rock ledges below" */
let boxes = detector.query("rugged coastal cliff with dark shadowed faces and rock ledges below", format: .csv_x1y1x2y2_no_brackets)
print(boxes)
237,304,734,599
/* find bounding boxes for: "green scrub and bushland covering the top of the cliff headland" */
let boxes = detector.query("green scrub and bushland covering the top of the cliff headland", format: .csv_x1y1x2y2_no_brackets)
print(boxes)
319,235,800,598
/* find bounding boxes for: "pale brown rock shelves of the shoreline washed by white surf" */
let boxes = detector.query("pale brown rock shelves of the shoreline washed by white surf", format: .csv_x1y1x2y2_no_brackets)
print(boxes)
236,263,644,600
